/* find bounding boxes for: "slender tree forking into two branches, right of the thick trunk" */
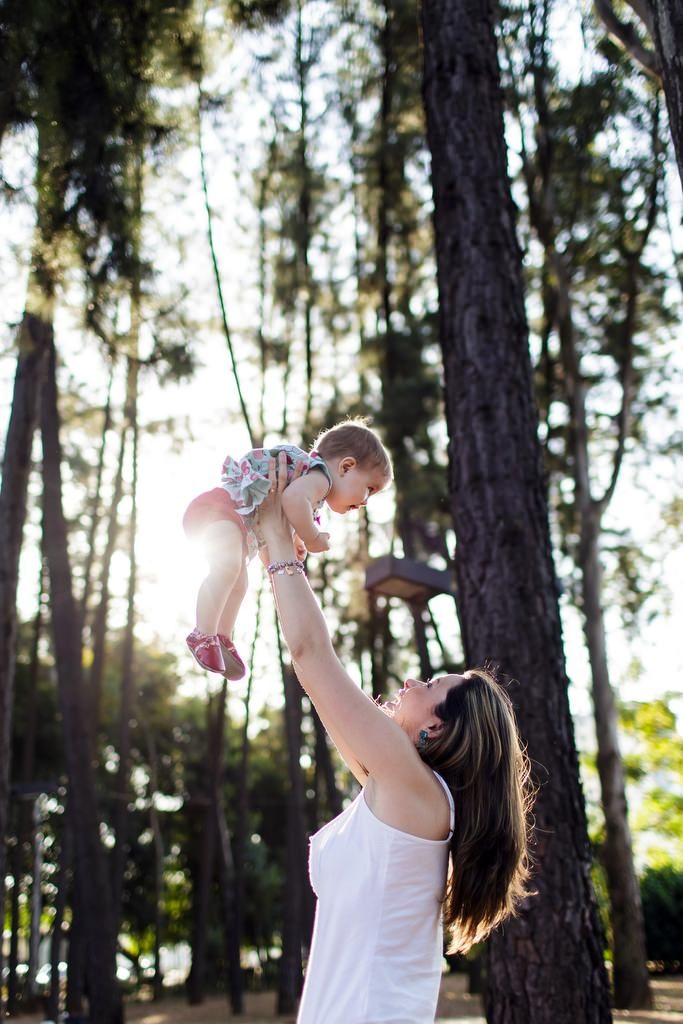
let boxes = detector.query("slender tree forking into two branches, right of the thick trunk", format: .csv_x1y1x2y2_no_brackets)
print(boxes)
524,70,658,1010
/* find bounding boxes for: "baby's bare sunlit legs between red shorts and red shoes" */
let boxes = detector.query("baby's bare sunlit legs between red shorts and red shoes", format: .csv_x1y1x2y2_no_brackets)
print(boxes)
197,519,246,636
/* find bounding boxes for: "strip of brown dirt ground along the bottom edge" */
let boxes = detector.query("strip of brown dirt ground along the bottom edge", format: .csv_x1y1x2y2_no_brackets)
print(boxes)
17,974,683,1024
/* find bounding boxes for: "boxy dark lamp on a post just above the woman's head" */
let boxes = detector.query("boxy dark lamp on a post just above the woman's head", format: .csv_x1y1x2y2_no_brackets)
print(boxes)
366,555,455,678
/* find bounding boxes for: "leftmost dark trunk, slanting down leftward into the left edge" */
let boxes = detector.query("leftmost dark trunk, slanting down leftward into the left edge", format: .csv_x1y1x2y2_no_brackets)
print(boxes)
0,312,52,999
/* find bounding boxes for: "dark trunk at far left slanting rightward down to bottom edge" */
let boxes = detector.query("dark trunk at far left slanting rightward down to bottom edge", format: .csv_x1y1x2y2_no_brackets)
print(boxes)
41,343,123,1024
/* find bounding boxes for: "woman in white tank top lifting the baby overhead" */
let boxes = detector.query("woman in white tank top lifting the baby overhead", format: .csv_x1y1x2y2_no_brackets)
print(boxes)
259,462,529,1024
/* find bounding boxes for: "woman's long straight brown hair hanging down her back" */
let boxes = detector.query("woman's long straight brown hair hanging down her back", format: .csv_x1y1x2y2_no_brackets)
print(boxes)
420,669,532,952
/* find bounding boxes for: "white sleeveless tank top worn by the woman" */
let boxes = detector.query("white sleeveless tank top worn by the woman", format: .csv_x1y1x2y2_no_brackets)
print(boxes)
297,772,455,1024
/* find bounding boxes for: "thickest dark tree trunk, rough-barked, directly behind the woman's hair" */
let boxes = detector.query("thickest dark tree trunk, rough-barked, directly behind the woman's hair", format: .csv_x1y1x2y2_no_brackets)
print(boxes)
423,0,611,1024
